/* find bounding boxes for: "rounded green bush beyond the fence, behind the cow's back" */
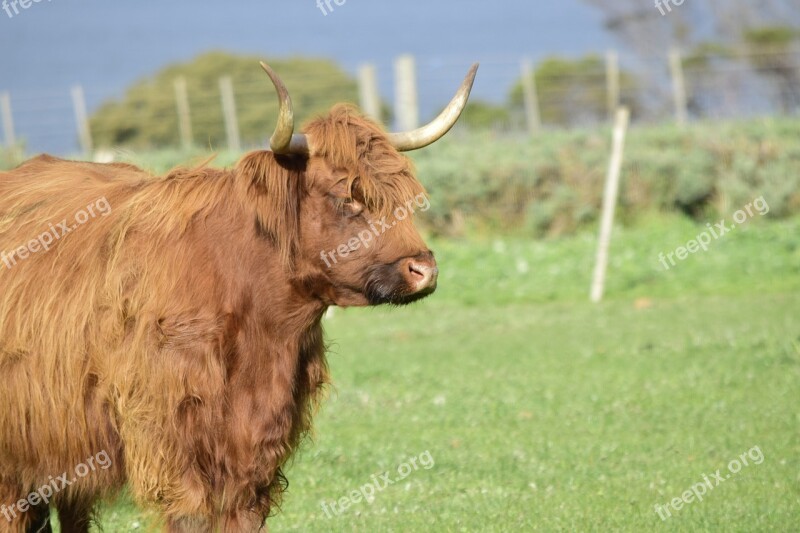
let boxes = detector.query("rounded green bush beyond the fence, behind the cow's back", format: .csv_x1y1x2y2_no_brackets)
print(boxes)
91,52,358,148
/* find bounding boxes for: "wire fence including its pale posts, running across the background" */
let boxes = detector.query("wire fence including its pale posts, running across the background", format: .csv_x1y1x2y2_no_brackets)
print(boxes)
0,49,800,154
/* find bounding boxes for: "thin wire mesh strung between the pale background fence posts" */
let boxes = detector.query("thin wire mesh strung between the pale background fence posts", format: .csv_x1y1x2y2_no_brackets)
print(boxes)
0,50,800,153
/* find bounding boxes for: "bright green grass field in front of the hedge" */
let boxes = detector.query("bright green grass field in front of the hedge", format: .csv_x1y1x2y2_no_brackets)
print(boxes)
59,214,800,532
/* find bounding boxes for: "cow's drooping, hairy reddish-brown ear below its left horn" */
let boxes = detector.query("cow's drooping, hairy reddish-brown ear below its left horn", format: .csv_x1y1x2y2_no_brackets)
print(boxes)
236,151,308,268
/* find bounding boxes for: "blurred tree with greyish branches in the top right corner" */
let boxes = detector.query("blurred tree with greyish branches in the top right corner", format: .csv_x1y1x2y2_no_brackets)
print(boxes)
584,0,800,114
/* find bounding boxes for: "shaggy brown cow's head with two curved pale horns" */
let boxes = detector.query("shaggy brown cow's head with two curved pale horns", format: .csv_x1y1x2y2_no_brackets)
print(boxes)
234,63,477,306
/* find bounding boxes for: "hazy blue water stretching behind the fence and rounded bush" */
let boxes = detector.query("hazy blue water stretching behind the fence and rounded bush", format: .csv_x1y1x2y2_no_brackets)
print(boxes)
0,0,613,153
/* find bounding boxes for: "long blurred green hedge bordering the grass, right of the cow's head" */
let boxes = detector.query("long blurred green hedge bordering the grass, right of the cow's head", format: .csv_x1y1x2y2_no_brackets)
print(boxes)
413,120,800,235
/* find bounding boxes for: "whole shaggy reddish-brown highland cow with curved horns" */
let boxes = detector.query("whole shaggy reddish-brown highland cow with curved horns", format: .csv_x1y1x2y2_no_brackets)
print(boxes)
0,60,477,532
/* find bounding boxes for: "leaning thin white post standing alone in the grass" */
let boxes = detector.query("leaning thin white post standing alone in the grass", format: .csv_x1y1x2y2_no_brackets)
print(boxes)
591,107,630,303
